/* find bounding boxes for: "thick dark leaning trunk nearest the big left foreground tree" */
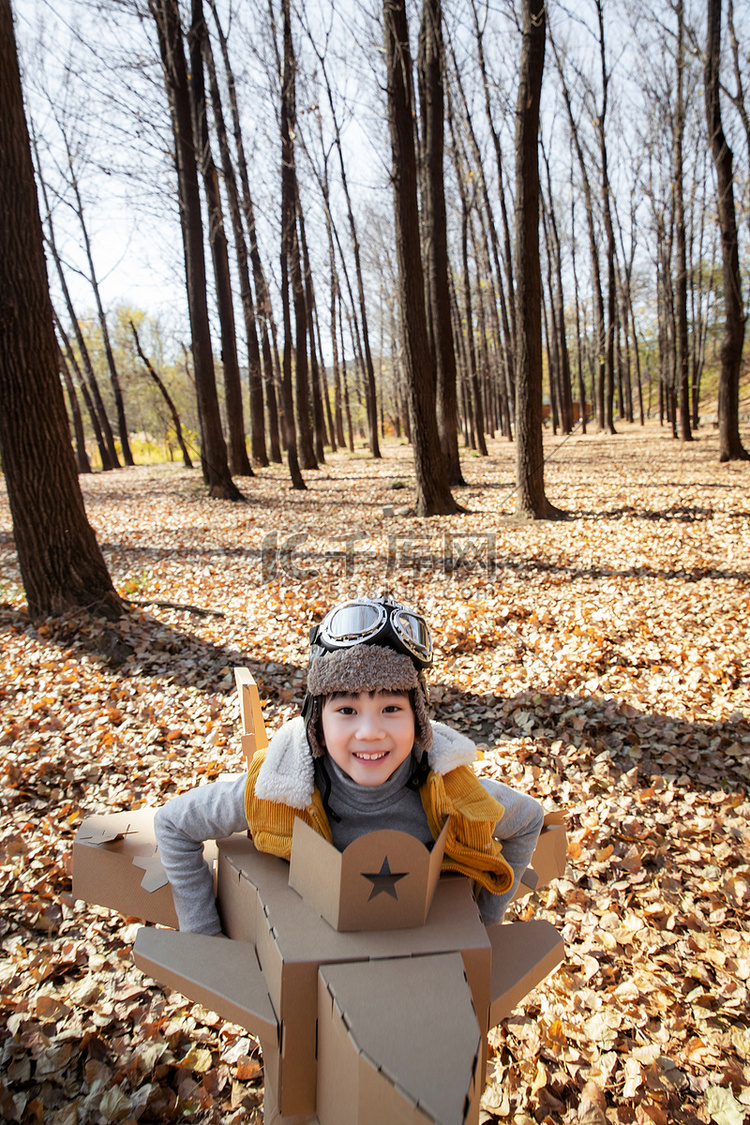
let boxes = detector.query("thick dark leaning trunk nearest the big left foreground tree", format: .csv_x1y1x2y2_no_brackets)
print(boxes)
150,0,243,501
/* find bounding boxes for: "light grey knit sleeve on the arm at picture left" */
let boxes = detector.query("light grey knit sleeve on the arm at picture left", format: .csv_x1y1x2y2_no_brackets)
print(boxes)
154,774,247,934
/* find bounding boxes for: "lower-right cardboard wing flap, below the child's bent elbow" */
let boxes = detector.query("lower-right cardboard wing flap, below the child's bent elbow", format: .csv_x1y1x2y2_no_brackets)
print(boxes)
487,918,564,1027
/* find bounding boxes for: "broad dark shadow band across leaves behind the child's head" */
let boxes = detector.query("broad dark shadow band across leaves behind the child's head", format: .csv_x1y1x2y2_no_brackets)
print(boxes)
0,604,750,793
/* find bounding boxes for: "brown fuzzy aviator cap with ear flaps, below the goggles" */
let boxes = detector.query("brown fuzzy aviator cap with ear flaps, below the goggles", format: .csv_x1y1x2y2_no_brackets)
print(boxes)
307,645,432,758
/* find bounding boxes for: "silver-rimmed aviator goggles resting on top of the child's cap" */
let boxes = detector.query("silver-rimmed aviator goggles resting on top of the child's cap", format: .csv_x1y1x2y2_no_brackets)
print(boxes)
310,599,432,668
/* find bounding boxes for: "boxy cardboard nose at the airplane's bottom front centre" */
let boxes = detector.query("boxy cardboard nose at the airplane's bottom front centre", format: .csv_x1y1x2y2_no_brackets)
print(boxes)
317,953,484,1125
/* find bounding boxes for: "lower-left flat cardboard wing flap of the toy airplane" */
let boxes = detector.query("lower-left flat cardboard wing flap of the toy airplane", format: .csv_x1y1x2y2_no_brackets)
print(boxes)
133,926,278,1044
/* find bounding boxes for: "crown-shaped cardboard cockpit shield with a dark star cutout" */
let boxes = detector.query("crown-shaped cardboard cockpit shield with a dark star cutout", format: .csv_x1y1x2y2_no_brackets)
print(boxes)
289,817,448,933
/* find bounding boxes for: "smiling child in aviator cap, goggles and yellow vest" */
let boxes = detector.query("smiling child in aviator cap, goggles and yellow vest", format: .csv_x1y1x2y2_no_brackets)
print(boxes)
154,599,543,934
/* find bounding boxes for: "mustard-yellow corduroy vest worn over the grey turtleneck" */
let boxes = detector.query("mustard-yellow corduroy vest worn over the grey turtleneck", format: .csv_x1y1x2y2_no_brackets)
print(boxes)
245,750,513,894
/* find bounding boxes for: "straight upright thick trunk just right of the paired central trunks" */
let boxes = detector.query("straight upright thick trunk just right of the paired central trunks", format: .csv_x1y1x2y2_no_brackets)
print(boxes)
515,0,561,520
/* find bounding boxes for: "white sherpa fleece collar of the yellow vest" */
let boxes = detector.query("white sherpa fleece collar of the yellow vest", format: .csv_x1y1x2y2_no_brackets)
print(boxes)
255,716,477,809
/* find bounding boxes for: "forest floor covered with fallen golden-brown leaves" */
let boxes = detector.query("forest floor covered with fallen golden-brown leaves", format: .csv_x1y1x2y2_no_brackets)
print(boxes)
0,425,750,1125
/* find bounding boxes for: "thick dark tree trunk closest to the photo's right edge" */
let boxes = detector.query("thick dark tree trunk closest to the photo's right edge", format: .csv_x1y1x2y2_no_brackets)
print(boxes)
705,0,750,461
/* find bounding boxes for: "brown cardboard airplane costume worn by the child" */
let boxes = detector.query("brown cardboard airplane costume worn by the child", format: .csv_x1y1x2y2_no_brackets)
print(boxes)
73,668,567,1125
